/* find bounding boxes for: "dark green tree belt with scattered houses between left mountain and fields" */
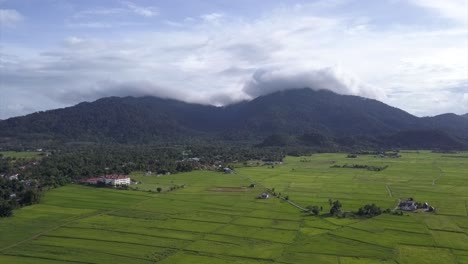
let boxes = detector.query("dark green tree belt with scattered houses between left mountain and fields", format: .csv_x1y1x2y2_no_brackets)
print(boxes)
0,144,285,216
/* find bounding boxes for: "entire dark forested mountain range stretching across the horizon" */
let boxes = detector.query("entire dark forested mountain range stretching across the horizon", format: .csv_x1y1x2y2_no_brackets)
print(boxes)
0,88,468,148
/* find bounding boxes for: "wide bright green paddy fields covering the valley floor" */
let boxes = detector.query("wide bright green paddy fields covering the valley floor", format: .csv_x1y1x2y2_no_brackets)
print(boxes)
0,152,468,264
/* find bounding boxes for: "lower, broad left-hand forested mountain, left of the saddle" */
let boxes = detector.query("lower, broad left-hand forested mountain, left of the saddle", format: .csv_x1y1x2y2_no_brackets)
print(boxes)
0,97,225,143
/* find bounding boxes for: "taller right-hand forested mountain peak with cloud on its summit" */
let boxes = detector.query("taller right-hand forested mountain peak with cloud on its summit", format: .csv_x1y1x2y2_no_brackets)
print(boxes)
223,88,419,136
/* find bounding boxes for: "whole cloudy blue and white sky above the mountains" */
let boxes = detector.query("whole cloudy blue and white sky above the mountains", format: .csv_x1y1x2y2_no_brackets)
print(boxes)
0,0,468,119
